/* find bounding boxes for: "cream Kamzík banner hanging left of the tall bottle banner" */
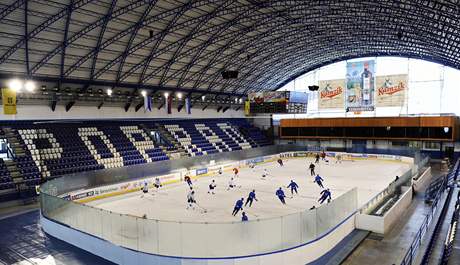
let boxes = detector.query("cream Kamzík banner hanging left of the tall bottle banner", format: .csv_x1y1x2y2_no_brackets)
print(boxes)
318,79,346,109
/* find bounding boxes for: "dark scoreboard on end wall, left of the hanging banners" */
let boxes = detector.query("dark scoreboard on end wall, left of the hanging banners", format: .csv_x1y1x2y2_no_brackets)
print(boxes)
245,91,308,115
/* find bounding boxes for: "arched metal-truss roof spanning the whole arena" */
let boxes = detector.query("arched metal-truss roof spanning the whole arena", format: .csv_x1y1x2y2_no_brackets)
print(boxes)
0,0,460,95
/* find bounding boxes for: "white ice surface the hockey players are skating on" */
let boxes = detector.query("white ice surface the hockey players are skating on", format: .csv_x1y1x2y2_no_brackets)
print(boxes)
87,158,410,223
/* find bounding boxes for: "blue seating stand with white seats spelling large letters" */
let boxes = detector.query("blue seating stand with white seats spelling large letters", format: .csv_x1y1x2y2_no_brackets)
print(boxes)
0,119,268,197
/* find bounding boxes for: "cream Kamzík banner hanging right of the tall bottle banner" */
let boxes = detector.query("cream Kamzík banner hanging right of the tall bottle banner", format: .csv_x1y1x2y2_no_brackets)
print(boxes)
375,74,408,107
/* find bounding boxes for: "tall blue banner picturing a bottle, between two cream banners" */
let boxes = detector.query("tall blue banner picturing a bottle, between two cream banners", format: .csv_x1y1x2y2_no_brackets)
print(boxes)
345,60,375,112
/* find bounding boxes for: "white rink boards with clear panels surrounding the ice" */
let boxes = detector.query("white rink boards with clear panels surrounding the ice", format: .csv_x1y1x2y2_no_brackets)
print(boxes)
42,152,413,265
